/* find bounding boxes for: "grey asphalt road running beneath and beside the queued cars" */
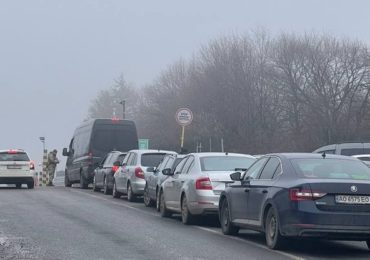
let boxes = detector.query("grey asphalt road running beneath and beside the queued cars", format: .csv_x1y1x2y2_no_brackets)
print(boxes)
0,187,370,260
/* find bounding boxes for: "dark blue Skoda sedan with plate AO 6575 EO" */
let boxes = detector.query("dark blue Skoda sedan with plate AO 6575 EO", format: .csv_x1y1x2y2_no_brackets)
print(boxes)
219,153,370,249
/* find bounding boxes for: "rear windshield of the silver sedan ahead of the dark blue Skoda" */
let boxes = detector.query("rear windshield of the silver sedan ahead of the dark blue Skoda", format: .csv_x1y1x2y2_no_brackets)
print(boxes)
200,155,256,171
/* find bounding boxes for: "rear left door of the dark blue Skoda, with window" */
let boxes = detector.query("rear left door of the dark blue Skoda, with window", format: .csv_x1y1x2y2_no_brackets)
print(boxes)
247,156,281,225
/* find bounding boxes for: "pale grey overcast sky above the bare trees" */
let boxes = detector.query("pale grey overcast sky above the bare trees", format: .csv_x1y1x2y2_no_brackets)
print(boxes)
0,0,370,168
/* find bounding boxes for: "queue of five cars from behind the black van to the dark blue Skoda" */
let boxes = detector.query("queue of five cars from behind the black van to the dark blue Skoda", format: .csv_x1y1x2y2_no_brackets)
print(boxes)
93,146,370,249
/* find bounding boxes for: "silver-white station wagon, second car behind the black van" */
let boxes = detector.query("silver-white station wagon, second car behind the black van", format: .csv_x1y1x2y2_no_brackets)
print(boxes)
113,150,176,201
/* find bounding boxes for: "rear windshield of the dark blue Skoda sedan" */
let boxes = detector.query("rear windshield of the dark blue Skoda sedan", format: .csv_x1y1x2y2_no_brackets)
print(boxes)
291,159,370,180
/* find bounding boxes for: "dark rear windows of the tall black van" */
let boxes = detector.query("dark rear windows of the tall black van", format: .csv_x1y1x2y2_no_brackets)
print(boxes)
92,125,138,153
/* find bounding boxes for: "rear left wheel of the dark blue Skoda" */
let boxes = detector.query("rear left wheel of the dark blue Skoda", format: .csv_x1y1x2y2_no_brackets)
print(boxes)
265,207,285,249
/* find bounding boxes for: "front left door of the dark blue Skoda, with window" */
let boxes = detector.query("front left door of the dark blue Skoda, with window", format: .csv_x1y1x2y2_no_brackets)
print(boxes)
229,157,268,224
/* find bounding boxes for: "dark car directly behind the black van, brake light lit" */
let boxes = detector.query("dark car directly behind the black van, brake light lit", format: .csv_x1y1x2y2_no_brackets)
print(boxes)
93,151,127,195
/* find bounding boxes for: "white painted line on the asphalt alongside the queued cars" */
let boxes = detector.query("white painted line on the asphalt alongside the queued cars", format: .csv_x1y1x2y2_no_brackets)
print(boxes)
69,189,305,260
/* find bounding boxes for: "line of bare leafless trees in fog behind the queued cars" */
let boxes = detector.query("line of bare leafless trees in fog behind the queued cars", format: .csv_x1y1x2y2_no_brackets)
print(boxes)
89,32,370,154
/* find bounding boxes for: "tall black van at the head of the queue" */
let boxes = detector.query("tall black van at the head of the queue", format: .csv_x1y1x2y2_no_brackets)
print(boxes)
63,119,138,189
